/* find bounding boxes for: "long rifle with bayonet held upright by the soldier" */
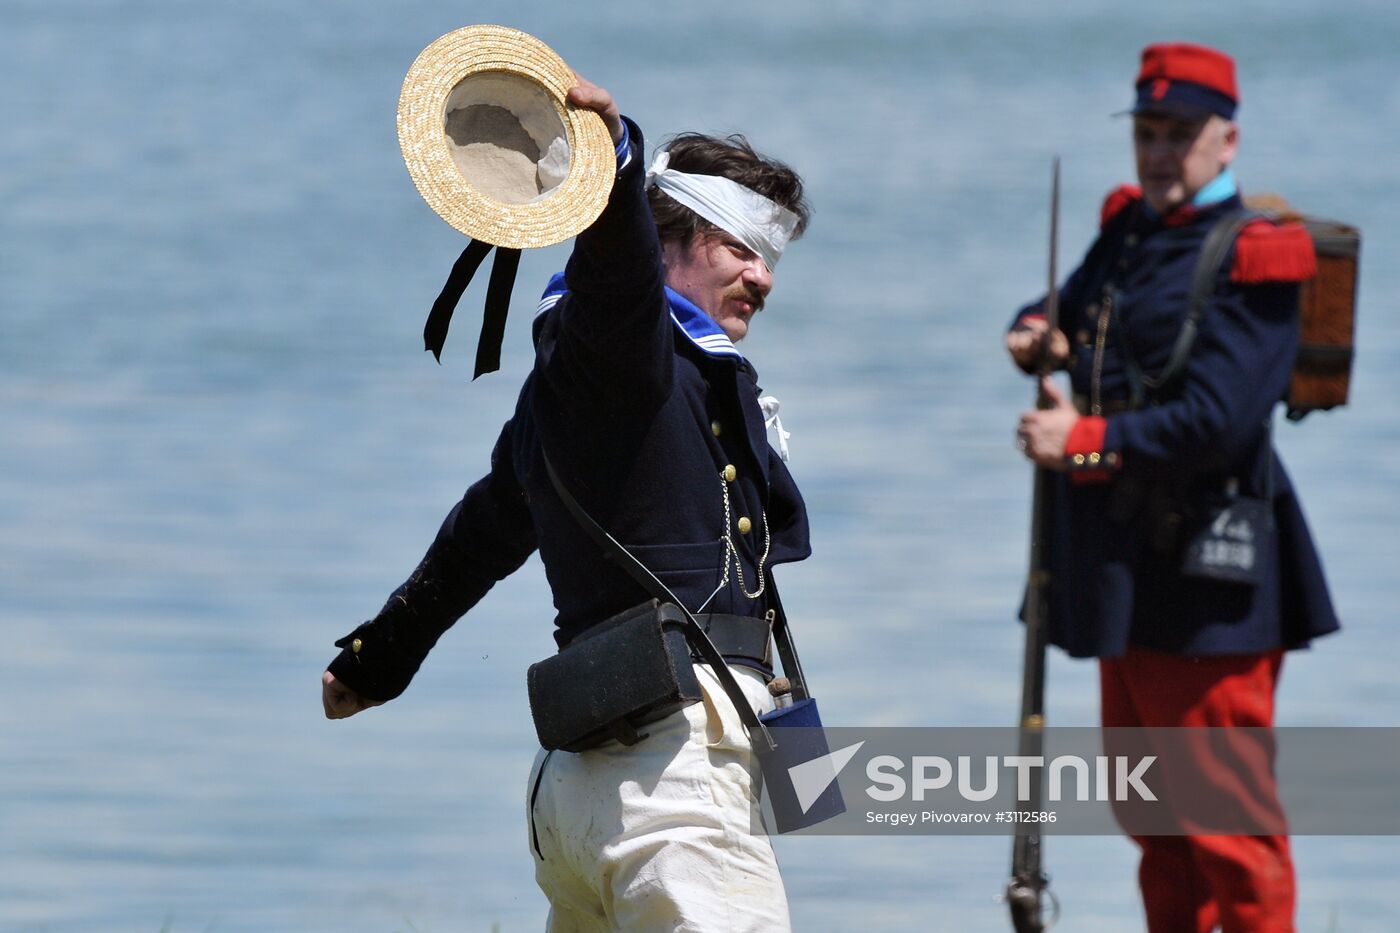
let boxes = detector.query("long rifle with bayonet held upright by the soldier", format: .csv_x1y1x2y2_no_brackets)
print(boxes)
1005,157,1060,933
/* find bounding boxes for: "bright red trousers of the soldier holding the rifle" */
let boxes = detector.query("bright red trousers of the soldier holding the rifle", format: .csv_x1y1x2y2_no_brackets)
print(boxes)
1099,649,1295,933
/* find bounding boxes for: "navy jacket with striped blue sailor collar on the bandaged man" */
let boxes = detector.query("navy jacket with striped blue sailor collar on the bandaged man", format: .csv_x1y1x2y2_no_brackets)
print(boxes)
329,120,811,700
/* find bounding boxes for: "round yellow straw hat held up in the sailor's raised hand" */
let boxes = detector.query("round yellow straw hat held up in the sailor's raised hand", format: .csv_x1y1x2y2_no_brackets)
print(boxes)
399,25,617,249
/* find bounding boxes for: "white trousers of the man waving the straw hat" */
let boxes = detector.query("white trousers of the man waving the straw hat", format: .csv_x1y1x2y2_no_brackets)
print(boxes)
526,664,791,933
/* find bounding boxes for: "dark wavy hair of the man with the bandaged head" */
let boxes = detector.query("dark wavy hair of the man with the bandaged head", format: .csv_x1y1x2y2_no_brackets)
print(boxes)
647,133,812,244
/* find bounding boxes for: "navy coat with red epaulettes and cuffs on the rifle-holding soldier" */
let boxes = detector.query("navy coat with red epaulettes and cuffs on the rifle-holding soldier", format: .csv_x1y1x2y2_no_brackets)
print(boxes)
1012,186,1338,657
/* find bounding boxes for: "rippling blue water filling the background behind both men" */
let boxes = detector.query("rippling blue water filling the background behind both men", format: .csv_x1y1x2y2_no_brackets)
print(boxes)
0,0,1400,933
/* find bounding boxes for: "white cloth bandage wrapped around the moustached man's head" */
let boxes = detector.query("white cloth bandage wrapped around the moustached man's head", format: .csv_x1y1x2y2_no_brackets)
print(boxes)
647,151,798,272
